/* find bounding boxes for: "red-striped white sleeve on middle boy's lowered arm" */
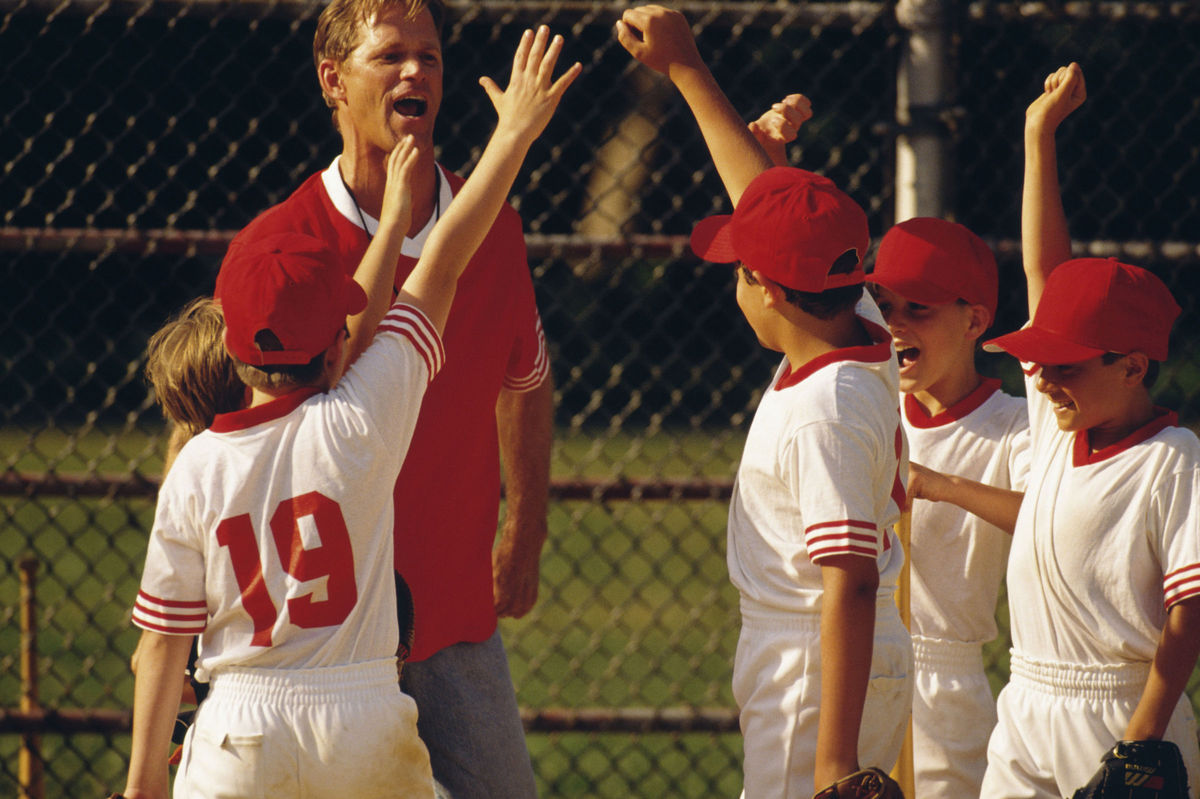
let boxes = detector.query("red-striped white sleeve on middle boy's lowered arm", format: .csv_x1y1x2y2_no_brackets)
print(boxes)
788,412,892,564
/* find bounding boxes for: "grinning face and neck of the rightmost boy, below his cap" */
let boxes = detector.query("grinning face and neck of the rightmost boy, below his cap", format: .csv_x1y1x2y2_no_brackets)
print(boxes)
1034,353,1154,451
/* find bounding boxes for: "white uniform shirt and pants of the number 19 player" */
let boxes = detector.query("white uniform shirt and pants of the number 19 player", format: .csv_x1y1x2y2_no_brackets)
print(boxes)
133,304,444,799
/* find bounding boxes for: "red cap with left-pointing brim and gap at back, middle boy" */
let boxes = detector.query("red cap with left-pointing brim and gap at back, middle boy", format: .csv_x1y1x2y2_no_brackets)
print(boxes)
691,167,871,293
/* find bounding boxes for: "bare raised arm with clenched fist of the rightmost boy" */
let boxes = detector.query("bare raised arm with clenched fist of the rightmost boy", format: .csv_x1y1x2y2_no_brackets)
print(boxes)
1021,62,1087,319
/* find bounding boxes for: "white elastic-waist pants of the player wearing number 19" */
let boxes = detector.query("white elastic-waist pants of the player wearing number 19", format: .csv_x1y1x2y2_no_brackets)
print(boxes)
174,659,433,799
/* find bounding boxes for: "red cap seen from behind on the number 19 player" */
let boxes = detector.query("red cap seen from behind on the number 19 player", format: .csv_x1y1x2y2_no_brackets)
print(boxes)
216,233,367,366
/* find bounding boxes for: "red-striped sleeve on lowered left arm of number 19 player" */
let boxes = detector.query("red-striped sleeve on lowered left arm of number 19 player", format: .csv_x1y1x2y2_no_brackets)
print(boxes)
133,479,209,635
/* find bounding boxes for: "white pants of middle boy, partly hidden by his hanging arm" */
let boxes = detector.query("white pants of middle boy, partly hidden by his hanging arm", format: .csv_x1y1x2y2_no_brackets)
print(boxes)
733,595,912,799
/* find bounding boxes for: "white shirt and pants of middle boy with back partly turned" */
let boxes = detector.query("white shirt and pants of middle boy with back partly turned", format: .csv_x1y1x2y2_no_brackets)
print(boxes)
727,294,912,799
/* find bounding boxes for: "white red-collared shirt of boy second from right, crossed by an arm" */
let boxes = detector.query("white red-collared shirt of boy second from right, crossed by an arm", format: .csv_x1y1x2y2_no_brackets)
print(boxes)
901,378,1030,644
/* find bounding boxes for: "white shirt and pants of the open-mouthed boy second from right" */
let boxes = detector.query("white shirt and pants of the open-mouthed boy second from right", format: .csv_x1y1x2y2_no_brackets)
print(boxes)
902,379,1028,799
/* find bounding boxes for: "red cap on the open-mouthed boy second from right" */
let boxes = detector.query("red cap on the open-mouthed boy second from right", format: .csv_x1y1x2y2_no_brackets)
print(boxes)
868,217,1000,317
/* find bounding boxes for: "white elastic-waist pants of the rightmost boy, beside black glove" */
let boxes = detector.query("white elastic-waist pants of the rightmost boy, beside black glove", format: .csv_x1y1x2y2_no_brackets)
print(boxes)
980,653,1200,799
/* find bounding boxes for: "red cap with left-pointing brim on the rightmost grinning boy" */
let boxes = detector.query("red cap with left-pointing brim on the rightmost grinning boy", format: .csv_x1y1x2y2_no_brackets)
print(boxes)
984,258,1180,366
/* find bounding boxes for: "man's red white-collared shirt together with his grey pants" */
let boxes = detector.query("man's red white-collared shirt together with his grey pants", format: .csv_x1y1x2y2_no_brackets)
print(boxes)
219,153,550,795
